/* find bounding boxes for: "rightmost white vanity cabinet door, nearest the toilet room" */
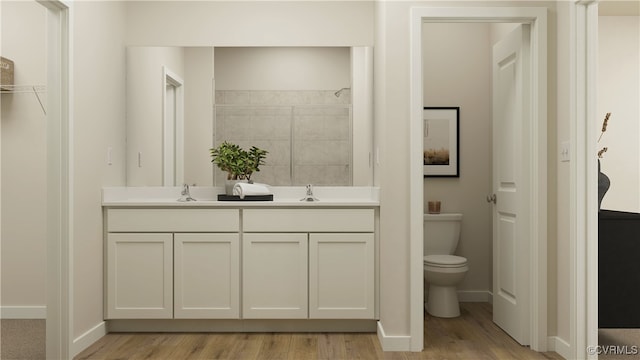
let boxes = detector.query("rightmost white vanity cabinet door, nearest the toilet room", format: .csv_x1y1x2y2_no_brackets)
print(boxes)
309,233,375,319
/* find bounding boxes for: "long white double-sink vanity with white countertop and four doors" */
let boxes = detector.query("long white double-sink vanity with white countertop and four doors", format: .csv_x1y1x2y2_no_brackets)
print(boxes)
103,187,379,332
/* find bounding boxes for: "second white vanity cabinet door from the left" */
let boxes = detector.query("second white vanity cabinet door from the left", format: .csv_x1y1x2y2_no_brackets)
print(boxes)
174,233,240,319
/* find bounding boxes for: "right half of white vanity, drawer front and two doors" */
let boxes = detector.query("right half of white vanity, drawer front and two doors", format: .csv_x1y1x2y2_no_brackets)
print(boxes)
243,208,375,319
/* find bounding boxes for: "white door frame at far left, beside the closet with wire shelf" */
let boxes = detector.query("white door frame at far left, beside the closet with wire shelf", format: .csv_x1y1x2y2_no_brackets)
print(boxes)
36,0,73,359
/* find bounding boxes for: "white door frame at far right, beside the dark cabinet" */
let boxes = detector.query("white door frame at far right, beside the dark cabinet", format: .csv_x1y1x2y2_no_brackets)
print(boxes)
568,0,599,359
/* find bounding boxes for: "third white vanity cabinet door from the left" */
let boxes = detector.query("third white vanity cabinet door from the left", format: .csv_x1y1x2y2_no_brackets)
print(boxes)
242,233,308,319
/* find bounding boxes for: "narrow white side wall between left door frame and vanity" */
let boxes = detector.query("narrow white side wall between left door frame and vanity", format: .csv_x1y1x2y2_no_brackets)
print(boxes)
71,1,125,348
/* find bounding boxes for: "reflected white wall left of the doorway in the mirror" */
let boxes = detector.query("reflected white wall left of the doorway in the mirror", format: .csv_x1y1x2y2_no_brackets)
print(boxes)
126,47,184,186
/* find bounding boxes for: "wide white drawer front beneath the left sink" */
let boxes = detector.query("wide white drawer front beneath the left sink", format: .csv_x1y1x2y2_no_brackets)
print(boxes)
107,209,240,232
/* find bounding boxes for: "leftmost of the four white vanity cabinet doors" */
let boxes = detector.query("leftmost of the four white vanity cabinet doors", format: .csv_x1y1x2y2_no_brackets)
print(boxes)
106,233,173,319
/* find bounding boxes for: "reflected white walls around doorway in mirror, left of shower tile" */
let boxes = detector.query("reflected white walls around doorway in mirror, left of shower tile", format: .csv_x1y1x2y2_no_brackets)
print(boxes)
126,46,213,186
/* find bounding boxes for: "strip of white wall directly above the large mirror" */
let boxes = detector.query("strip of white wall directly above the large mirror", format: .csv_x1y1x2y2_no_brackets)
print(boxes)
127,1,374,47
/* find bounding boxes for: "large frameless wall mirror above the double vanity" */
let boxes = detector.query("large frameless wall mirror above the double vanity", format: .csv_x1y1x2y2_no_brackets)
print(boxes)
127,47,373,186
